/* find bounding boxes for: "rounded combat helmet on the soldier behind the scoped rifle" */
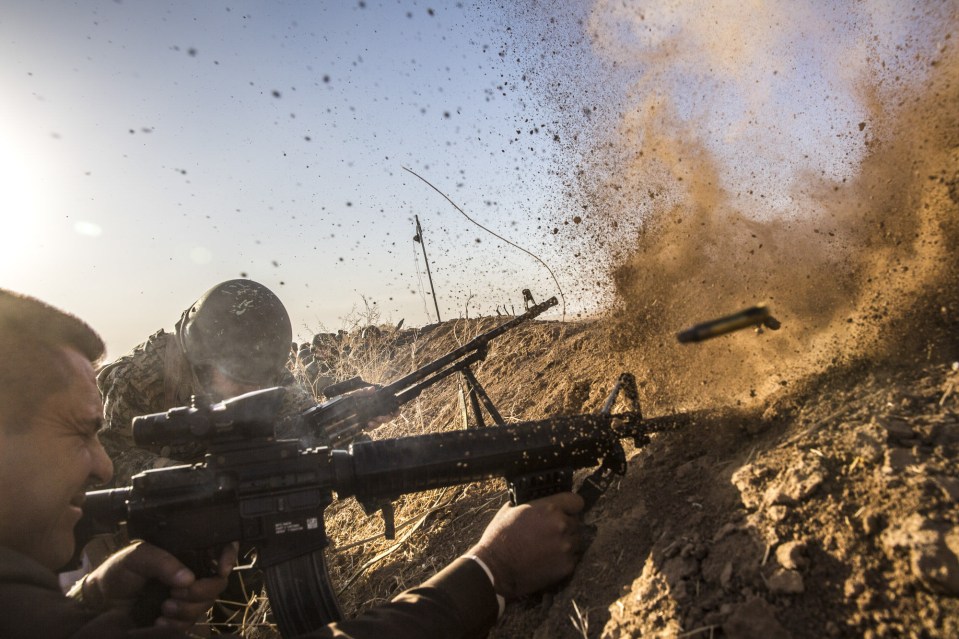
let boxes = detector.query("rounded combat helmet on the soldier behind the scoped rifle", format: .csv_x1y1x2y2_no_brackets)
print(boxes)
176,280,293,386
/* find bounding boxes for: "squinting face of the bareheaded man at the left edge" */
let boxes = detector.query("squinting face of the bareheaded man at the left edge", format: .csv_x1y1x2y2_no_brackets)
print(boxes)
0,349,113,570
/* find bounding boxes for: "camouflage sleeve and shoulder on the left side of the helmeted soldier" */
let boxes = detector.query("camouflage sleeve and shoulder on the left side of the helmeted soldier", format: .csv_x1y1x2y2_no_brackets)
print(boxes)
97,330,181,486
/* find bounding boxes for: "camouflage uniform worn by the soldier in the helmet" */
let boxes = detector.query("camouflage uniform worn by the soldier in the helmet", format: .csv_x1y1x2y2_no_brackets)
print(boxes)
97,329,325,486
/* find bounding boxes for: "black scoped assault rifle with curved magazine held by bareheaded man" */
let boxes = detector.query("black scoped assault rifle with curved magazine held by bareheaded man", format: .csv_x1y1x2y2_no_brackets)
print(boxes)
78,373,689,638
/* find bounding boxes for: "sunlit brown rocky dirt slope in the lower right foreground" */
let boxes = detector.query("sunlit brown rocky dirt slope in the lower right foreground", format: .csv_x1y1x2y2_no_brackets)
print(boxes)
512,356,959,637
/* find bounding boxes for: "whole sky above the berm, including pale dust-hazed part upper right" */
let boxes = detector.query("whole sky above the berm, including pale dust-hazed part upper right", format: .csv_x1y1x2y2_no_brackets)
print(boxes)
0,0,959,358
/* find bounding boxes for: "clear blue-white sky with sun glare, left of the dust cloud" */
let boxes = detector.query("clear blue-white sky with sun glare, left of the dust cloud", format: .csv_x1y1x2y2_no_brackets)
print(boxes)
0,0,568,357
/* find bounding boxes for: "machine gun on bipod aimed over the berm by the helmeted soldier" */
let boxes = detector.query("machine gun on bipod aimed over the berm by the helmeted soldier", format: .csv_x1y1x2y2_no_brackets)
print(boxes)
293,290,558,446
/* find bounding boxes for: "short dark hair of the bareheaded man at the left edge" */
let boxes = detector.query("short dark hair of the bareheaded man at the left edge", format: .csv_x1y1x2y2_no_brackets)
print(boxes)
0,289,104,430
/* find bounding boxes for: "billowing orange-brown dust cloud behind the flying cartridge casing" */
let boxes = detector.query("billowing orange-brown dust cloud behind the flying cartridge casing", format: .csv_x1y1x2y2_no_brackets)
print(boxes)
510,2,959,410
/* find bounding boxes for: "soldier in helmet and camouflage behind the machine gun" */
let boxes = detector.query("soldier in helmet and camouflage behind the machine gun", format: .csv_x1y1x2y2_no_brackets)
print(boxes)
97,280,322,486
